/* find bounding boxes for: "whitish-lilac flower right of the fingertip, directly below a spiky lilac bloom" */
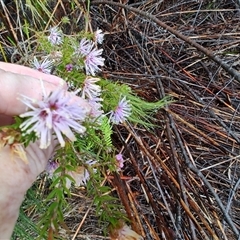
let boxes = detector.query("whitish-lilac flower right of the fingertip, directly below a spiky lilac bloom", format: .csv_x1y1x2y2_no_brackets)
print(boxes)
82,77,102,99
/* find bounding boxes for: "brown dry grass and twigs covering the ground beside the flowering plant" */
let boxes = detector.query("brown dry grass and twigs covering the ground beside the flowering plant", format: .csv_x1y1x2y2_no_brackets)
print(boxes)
1,0,240,240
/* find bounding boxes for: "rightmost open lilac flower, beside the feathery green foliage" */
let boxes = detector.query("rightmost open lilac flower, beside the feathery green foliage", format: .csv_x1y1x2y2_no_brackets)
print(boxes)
110,97,132,124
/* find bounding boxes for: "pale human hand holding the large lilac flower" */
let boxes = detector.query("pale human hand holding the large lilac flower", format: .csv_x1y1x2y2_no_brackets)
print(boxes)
0,62,88,240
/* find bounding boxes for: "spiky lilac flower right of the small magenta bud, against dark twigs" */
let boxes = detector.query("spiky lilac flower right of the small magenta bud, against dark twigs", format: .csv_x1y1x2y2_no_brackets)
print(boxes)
84,48,105,76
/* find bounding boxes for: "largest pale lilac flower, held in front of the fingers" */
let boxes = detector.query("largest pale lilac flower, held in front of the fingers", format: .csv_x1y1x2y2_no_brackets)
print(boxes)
20,88,91,149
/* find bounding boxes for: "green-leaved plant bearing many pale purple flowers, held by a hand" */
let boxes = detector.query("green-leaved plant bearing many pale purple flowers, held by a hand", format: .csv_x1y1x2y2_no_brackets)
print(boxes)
4,24,169,238
